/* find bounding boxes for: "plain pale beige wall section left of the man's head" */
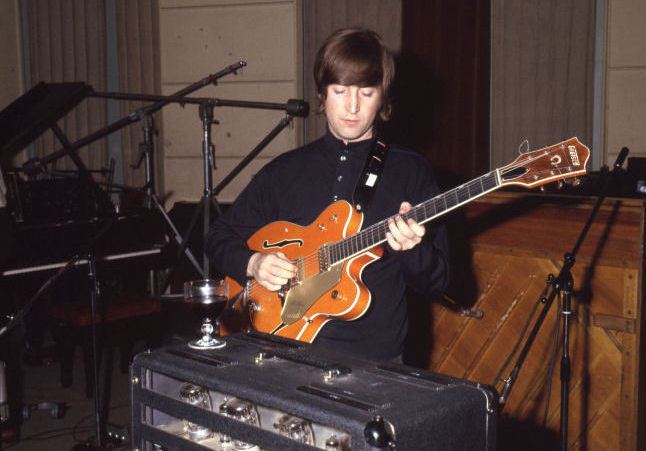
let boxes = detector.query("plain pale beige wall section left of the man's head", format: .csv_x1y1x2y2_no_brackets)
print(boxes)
159,0,302,202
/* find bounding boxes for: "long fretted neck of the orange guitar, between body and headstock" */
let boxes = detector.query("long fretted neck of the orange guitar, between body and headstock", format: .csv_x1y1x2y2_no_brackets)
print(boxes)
327,170,501,264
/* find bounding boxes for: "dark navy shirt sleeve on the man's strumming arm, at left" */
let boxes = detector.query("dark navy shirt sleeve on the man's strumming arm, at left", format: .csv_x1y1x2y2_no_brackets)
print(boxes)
206,169,271,284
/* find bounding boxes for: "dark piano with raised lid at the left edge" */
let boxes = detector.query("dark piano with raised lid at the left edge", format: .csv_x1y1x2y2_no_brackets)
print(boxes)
0,82,166,279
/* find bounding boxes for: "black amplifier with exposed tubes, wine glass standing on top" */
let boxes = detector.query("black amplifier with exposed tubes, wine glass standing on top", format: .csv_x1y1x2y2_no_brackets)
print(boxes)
131,333,498,451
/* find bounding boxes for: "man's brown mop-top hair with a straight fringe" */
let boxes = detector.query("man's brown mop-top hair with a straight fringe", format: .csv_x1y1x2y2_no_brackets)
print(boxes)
314,28,395,120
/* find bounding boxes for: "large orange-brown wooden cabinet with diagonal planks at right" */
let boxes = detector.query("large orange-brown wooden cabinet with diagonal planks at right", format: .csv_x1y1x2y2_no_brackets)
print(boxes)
427,192,646,450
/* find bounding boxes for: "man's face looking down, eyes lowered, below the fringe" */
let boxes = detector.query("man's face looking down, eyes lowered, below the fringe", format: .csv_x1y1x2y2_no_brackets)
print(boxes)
323,85,381,143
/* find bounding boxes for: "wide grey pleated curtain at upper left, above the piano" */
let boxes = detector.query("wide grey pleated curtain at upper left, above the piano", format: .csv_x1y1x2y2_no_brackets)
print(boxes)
26,0,107,173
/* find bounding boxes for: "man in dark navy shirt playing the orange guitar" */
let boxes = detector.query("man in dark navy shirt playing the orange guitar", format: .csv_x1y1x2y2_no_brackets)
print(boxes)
207,29,448,360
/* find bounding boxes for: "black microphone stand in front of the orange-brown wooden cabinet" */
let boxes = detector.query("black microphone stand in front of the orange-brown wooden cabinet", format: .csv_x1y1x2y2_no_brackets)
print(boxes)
499,147,628,450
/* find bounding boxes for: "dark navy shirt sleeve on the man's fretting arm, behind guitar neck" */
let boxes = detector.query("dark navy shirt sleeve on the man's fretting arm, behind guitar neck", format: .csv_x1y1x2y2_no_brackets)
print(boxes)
386,157,450,297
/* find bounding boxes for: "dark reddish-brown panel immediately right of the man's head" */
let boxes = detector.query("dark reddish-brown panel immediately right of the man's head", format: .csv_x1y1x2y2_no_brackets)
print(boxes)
388,0,490,187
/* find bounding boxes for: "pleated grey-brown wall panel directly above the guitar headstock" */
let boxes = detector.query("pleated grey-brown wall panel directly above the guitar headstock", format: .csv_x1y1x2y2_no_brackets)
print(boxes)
491,0,603,168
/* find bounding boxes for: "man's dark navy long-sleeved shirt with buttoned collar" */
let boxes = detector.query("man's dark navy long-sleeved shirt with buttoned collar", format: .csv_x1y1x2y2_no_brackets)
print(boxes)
207,132,449,360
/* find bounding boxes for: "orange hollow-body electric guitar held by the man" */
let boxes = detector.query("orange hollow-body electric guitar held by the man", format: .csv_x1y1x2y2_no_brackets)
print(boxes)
222,138,590,343
